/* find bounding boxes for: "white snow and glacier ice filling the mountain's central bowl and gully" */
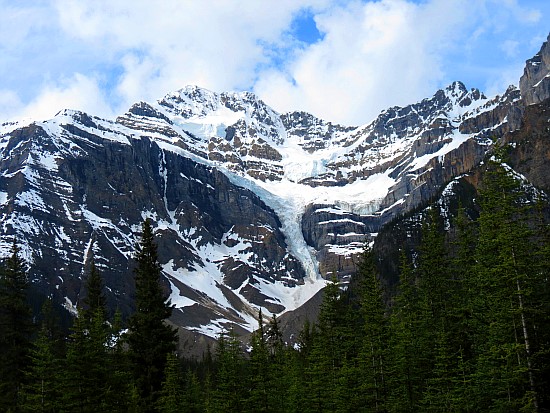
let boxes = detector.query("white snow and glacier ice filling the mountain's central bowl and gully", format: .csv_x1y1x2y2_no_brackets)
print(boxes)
0,80,500,332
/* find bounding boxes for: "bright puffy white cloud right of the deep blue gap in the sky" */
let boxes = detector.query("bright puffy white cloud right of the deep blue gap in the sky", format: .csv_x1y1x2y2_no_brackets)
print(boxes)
255,0,474,124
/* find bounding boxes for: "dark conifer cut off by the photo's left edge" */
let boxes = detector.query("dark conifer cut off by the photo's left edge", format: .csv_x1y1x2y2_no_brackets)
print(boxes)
0,240,34,411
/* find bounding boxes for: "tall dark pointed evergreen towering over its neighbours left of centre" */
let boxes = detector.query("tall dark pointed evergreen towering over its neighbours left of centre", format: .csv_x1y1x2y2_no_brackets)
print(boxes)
127,219,177,411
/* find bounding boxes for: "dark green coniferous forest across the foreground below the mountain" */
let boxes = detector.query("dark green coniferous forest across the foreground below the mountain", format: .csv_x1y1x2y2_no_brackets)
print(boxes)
0,156,550,413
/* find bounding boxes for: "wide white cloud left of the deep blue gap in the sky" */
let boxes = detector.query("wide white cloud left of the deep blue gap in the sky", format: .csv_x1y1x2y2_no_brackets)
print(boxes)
51,0,330,108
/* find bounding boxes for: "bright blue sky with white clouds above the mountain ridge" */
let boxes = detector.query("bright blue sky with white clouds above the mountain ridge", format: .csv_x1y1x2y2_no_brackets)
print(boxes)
0,0,550,125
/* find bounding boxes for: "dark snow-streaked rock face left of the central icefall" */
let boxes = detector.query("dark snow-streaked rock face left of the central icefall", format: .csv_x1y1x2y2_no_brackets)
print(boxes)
0,112,305,326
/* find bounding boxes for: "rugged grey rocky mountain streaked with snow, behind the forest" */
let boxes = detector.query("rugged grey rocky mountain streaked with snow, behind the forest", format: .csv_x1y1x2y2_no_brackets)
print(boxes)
0,34,550,336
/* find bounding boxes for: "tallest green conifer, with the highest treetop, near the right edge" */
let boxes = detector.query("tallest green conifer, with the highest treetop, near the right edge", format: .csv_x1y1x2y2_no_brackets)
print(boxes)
473,157,539,411
